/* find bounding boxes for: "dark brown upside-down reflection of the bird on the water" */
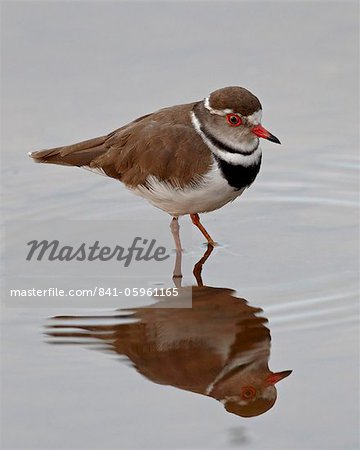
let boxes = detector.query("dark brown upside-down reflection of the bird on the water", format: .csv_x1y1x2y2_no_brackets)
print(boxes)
47,248,291,417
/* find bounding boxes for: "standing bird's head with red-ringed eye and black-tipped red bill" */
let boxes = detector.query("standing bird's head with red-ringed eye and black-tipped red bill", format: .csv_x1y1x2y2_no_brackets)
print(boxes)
192,86,280,154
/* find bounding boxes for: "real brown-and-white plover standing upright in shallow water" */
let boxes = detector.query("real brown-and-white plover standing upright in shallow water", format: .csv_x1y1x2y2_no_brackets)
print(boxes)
29,86,280,250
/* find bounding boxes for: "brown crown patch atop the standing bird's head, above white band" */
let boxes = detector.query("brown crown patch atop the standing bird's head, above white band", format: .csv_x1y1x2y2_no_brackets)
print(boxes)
209,86,261,116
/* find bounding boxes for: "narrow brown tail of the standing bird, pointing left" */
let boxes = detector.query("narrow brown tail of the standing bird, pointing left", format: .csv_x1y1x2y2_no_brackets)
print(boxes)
29,136,108,167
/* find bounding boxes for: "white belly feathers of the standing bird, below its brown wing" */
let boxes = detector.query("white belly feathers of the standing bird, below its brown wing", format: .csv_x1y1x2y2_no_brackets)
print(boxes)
133,163,244,216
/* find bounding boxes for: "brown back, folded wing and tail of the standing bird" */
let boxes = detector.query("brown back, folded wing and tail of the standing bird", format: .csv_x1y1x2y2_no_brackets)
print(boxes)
31,103,212,187
